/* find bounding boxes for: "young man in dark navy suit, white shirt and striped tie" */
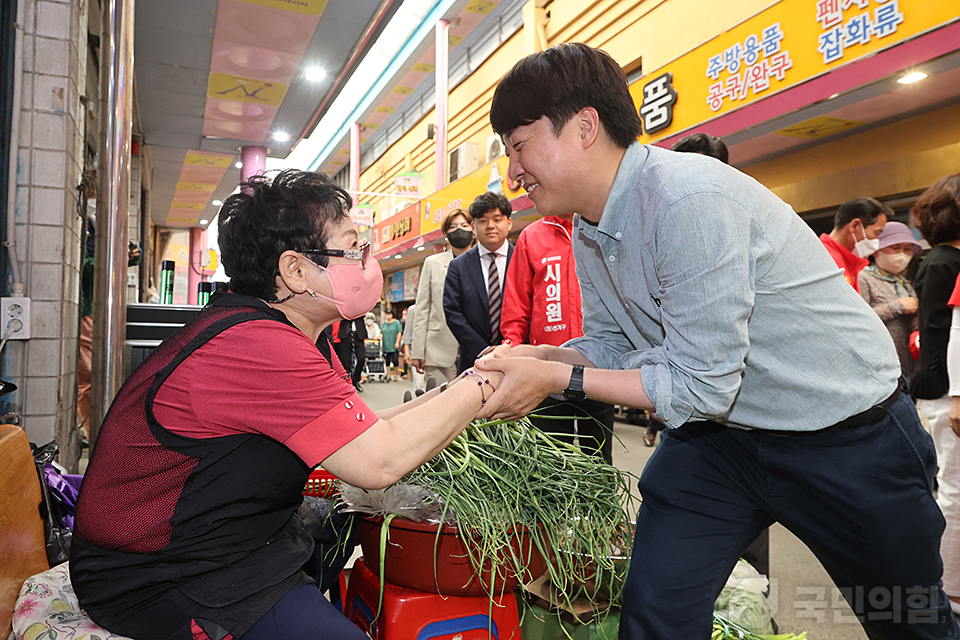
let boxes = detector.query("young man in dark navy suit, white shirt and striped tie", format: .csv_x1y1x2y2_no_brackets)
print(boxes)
443,191,513,373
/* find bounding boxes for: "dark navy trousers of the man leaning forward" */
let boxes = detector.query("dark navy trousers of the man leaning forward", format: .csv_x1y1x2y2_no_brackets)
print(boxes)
620,393,960,640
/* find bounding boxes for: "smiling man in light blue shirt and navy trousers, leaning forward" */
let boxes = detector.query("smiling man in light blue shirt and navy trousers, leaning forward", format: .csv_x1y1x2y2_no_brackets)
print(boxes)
478,44,960,640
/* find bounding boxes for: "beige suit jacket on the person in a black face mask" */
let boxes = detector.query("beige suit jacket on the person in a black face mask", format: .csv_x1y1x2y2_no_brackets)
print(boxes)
410,251,459,367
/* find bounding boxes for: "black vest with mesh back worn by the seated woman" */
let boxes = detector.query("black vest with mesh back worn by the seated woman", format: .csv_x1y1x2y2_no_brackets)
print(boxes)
70,294,314,640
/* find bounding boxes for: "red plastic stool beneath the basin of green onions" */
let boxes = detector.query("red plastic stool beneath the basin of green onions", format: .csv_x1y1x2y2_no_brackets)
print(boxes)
344,558,520,640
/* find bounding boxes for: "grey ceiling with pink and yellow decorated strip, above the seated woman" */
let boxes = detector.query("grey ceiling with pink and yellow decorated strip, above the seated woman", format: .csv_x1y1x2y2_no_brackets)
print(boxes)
134,0,400,227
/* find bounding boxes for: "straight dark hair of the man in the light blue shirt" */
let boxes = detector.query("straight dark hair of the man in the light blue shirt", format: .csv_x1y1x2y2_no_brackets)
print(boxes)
490,42,643,149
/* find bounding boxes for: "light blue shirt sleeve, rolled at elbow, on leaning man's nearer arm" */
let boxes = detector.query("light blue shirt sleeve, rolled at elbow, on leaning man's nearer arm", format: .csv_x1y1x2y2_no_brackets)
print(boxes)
636,193,756,427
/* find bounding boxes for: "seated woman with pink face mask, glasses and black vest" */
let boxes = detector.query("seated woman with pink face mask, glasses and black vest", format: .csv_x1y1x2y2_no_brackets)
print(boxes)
70,170,501,640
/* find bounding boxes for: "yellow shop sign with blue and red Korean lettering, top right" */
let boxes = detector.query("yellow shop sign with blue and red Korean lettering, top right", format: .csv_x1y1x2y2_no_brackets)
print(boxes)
630,0,957,142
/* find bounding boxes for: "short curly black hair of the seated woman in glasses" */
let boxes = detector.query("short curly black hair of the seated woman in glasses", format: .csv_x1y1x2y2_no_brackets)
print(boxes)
218,169,352,300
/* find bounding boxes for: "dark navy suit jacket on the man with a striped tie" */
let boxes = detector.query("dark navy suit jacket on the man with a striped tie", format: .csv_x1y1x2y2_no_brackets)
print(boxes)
443,242,513,371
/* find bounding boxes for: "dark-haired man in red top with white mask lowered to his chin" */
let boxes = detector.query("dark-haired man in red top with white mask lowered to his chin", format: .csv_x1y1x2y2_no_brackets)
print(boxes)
820,198,893,293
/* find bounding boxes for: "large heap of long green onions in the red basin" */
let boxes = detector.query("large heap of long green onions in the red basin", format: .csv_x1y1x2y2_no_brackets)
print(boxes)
403,419,636,610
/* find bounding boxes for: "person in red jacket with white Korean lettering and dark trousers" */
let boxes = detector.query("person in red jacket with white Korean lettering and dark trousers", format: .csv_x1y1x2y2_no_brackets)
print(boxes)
500,214,614,462
